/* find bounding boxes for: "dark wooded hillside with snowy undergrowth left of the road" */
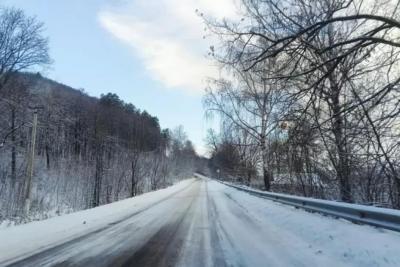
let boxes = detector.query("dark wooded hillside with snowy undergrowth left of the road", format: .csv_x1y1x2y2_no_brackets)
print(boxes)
0,7,207,224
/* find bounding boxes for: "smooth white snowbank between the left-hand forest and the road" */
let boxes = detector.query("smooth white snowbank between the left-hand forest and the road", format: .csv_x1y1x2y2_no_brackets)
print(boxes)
0,178,195,265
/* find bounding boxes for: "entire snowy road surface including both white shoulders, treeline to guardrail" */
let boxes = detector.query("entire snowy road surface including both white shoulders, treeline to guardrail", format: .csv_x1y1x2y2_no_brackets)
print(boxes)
0,179,400,267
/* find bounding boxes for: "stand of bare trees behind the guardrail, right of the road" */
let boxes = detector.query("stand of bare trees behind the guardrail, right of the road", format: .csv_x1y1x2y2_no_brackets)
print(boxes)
205,0,400,209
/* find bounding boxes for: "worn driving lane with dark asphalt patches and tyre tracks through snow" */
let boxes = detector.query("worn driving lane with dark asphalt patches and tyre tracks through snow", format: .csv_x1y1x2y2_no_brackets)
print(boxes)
9,180,226,266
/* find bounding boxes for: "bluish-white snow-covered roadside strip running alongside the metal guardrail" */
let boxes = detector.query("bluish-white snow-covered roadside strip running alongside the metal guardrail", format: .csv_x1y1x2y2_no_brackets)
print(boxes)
209,181,400,266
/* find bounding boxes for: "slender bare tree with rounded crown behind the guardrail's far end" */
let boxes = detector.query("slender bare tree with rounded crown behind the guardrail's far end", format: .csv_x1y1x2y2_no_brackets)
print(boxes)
204,61,289,190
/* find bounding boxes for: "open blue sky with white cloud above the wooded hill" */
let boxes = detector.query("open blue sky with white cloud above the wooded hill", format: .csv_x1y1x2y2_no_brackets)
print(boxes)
1,0,238,154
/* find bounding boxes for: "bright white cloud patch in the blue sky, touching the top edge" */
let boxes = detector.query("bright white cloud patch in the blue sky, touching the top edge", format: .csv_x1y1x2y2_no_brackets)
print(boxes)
99,0,235,93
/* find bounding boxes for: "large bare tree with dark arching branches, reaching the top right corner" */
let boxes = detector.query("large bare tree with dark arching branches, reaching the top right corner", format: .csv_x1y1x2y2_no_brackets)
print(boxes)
207,0,400,205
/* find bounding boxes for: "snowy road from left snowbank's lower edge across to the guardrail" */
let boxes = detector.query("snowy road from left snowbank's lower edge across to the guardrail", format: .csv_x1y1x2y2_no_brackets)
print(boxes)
3,179,400,266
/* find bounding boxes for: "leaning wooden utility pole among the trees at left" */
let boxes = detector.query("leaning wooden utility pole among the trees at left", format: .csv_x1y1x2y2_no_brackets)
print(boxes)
24,108,38,214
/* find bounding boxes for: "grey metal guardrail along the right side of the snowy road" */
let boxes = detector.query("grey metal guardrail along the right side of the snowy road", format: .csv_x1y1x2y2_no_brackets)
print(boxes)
219,178,400,232
